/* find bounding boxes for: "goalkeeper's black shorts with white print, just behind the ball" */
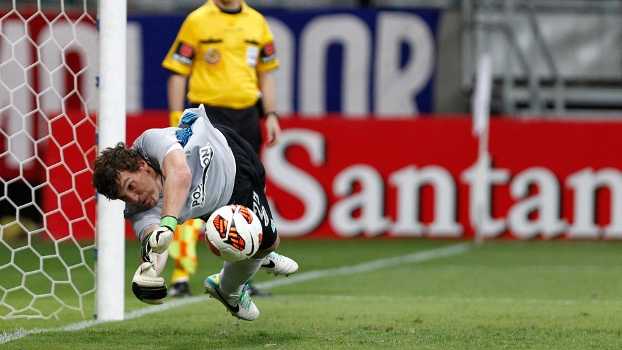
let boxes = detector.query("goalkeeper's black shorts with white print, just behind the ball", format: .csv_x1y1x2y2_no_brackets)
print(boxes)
214,124,277,249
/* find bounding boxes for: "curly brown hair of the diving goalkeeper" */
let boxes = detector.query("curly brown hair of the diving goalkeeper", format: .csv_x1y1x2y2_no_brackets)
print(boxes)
91,142,143,199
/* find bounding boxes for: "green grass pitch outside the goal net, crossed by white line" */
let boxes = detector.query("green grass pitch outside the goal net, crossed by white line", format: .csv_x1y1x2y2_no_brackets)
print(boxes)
0,239,622,350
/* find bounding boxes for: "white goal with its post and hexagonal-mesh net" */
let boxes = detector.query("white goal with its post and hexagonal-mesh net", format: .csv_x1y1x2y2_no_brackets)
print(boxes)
0,0,127,320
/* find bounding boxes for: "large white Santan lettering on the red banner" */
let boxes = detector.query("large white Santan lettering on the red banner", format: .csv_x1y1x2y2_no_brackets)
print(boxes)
264,129,622,239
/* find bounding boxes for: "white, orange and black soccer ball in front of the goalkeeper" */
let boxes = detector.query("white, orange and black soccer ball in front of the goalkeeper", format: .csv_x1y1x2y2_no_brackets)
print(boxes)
205,204,263,262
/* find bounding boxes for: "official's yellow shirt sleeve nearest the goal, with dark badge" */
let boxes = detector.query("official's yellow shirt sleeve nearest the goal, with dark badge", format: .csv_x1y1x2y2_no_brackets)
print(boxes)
162,16,197,76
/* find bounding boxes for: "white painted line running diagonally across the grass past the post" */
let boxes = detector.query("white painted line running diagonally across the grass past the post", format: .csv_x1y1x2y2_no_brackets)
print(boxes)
0,243,472,344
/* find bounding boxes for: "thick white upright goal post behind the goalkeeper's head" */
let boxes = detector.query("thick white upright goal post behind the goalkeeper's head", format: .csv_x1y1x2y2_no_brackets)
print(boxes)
96,0,127,321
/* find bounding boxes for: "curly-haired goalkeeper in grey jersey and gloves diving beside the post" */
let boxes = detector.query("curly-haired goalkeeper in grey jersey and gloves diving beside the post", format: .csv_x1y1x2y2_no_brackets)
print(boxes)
92,105,298,321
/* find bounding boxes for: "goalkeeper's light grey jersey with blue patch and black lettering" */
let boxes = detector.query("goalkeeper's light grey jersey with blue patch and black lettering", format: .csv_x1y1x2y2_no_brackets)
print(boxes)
124,105,236,237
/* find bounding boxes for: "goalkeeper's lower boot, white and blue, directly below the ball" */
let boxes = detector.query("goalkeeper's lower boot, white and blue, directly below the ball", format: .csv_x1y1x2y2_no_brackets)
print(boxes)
205,274,259,321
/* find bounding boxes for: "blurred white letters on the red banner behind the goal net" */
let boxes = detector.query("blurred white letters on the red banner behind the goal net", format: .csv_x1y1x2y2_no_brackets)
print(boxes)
0,19,98,171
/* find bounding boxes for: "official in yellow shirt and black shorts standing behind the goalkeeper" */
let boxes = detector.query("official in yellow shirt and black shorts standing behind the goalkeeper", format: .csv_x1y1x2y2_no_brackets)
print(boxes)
162,0,281,296
